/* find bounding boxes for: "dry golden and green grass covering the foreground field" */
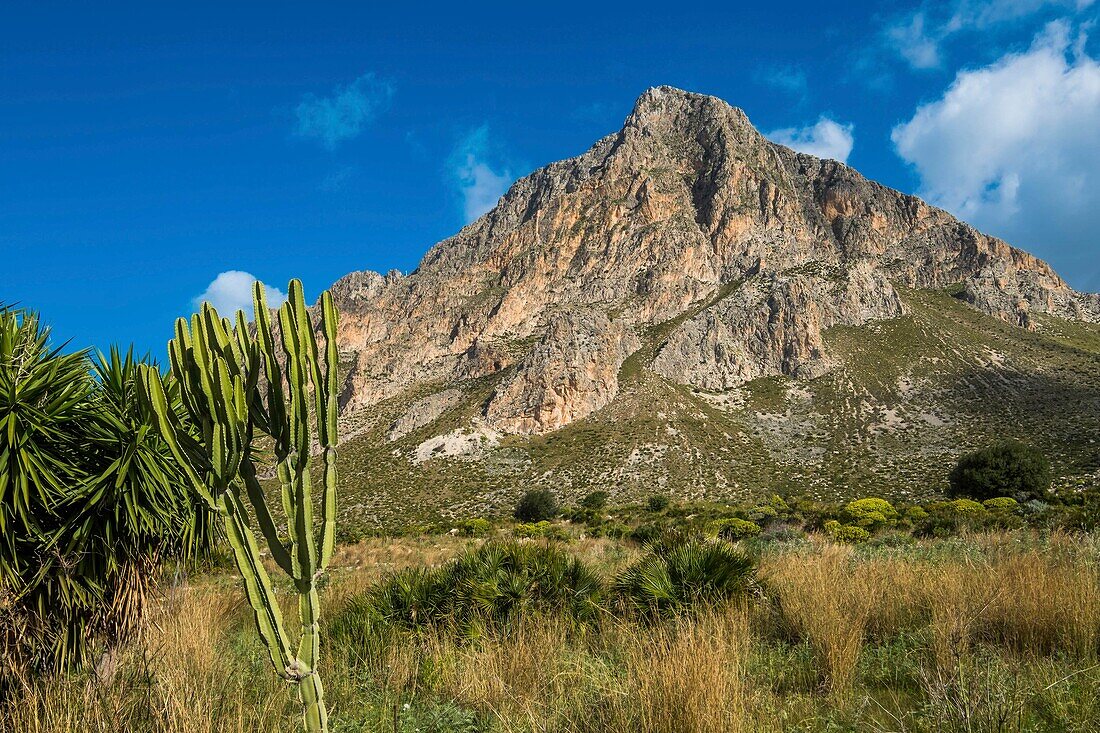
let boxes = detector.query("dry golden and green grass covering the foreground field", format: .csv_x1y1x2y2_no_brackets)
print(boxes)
0,530,1100,733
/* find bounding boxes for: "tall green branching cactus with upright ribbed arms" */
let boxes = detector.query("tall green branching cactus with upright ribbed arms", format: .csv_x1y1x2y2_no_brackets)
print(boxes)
142,280,338,732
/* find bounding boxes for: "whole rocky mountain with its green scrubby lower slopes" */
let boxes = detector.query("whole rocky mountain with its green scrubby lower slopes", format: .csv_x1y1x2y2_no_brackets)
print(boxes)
321,87,1100,524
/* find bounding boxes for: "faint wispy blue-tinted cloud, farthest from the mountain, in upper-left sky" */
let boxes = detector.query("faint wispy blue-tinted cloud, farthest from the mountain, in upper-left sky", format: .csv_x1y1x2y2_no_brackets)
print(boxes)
294,74,394,150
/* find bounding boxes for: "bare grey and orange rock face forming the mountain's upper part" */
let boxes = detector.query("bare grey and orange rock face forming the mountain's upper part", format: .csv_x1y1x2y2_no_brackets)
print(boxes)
332,87,1100,434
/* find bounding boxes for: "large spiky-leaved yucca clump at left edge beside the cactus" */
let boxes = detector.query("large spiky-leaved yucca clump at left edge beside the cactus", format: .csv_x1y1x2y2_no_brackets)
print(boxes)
0,309,210,669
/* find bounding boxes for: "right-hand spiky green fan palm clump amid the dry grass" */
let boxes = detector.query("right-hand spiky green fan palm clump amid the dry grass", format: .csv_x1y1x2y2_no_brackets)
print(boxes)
615,539,756,617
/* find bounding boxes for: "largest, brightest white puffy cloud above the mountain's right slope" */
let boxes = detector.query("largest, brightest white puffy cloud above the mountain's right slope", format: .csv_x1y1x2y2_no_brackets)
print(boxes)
891,22,1100,283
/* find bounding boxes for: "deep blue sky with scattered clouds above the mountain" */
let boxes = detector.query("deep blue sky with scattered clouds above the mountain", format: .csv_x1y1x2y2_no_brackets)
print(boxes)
0,0,1100,354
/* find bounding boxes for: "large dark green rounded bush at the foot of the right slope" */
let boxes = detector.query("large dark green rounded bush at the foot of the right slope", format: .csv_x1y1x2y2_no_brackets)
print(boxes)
950,440,1053,502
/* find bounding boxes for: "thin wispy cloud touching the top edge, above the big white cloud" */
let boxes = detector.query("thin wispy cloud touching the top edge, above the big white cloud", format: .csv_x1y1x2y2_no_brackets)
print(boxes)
884,0,1095,69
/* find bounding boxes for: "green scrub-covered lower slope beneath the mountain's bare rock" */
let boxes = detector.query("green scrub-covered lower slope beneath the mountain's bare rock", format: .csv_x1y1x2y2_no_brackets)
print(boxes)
325,291,1100,540
